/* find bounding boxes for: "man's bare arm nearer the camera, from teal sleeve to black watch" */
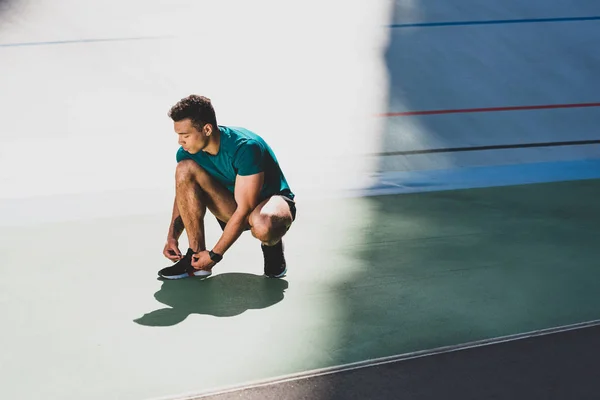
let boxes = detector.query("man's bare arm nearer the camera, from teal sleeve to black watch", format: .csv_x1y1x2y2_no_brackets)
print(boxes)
212,172,265,255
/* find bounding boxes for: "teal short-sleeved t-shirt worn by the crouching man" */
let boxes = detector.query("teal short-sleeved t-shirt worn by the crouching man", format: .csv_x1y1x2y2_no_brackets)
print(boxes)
177,125,294,201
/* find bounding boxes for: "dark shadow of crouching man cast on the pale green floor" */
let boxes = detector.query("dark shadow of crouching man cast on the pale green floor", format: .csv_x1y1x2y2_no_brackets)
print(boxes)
134,273,289,326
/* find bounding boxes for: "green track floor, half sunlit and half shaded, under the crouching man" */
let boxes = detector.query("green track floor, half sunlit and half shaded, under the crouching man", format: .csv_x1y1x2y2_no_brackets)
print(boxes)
0,180,600,400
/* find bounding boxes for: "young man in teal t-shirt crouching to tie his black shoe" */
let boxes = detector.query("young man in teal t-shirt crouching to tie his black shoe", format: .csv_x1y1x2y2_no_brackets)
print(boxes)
158,95,296,279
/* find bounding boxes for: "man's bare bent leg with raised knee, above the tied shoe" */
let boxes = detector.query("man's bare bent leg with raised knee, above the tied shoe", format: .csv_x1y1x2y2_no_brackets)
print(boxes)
175,160,237,252
